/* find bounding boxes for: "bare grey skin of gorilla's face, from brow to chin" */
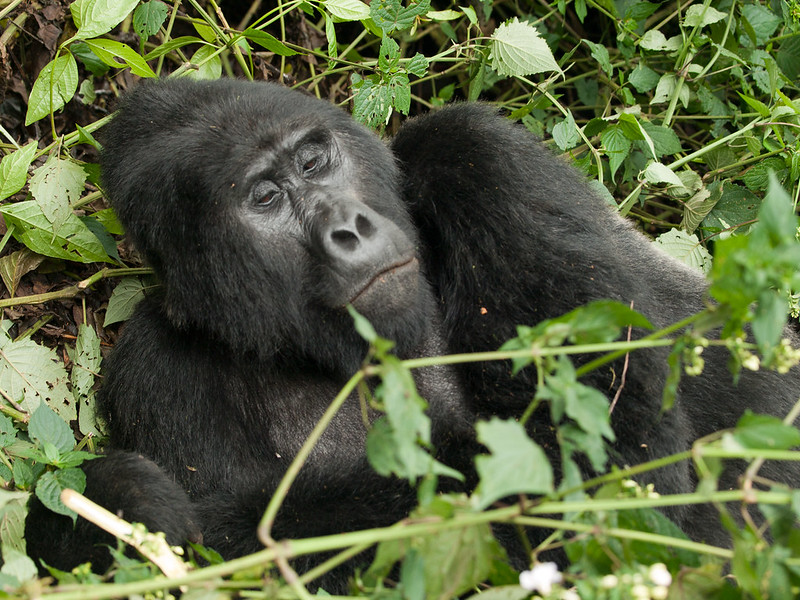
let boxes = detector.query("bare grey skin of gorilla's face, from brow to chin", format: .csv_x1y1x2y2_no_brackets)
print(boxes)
237,120,419,320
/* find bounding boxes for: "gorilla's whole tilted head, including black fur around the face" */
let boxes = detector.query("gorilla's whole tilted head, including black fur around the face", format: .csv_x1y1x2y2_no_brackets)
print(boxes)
102,81,435,372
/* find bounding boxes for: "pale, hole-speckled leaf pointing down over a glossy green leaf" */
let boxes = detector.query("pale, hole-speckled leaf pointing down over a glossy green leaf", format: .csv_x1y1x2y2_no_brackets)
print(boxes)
29,155,86,231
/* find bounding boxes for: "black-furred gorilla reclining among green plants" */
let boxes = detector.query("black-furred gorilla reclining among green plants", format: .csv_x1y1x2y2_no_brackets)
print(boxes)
27,80,800,590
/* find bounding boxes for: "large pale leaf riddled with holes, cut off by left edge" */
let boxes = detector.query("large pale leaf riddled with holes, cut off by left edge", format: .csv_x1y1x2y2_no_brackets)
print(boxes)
0,333,76,421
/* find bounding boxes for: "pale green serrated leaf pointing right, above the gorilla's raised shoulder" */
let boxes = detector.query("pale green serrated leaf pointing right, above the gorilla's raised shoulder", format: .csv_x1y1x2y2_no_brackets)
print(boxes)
489,17,561,77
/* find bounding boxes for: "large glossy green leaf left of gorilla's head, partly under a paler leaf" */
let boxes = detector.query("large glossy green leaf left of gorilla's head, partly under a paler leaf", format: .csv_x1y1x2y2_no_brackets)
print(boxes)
0,200,113,263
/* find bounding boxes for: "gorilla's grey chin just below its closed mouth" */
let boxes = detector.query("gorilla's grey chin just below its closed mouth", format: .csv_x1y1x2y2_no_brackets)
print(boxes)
350,257,420,318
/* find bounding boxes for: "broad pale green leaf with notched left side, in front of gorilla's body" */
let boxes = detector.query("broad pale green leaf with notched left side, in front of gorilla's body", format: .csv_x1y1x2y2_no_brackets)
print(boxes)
473,417,553,510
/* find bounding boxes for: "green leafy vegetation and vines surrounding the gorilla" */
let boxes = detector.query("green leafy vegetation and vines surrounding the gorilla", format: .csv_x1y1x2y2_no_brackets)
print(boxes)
0,0,800,600
